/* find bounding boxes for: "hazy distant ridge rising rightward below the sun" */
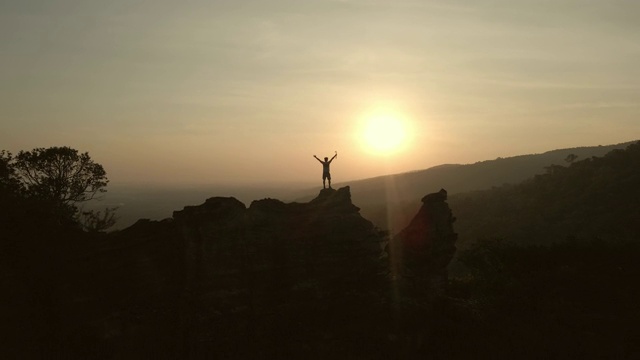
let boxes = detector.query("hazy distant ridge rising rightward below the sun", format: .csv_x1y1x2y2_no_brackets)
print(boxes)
324,142,633,232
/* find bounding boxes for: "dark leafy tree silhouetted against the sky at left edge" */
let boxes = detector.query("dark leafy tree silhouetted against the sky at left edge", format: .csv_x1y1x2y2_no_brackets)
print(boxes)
0,147,116,231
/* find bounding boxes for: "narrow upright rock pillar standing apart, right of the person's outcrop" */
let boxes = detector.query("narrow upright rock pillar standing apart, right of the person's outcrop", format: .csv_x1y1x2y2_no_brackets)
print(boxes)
387,189,458,298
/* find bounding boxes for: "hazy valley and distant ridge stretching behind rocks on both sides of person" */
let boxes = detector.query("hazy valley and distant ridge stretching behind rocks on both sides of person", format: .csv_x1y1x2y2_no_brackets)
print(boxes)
102,143,631,230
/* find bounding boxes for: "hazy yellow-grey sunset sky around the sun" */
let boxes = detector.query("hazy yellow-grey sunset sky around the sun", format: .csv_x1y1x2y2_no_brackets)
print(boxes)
0,0,640,184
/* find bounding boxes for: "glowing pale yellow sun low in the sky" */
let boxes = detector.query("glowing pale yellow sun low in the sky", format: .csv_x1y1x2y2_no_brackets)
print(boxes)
361,114,408,154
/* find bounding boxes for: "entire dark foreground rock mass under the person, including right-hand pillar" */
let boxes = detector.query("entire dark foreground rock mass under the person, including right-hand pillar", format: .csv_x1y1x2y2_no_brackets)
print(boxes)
2,187,455,358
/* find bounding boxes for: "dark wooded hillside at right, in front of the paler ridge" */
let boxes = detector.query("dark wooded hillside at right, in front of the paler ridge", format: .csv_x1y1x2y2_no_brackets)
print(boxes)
449,142,640,246
